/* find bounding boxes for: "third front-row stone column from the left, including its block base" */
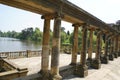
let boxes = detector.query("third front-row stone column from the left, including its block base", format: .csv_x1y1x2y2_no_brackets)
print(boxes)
92,31,102,69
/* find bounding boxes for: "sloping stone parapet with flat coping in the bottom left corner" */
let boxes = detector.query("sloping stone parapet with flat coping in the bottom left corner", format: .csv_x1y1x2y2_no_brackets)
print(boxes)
0,58,28,80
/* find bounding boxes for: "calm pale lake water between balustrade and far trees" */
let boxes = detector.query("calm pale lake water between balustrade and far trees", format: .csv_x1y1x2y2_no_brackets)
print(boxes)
0,37,41,52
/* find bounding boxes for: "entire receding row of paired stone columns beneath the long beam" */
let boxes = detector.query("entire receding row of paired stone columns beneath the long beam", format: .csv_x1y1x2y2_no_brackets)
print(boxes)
40,14,120,80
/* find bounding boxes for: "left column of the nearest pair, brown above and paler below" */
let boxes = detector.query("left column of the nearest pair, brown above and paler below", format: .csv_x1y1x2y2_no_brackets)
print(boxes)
40,16,50,80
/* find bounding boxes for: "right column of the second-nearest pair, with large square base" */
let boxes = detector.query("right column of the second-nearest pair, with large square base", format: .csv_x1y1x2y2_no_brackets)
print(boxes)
76,24,88,77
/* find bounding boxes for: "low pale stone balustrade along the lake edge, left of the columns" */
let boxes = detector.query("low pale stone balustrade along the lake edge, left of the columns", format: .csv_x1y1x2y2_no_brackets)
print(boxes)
0,50,42,59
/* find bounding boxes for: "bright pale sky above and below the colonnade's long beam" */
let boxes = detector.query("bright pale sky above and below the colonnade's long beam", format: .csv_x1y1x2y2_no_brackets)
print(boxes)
0,0,120,32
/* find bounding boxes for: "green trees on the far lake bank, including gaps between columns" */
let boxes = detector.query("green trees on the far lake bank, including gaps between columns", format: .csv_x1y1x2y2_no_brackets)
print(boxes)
0,27,104,48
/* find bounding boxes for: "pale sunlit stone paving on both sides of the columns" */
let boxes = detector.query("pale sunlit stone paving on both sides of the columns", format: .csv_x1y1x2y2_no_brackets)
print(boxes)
10,54,120,80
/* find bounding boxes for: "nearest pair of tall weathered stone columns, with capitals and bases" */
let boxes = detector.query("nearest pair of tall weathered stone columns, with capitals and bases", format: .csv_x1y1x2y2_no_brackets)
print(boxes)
40,13,62,80
